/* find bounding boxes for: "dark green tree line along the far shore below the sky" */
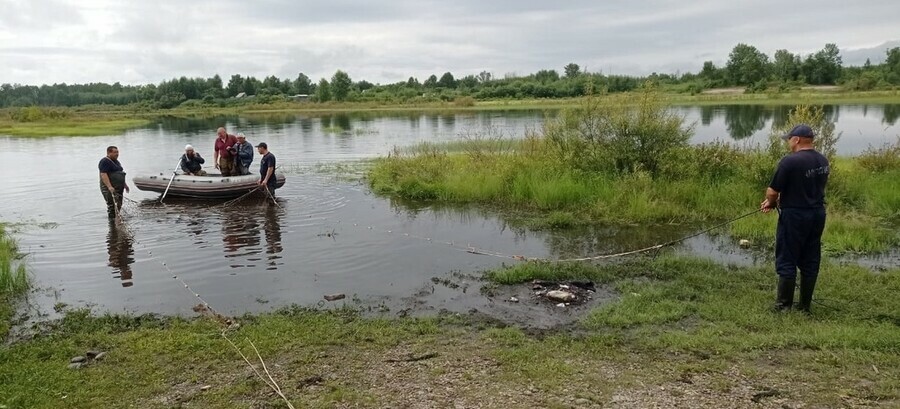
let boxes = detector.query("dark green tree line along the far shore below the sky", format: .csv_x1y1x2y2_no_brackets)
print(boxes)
0,43,900,108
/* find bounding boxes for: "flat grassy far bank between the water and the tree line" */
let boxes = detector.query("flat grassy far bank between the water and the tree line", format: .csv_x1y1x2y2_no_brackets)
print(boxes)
0,91,900,137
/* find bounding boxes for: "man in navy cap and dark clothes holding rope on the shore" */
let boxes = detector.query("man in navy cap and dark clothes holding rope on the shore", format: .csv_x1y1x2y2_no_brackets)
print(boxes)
760,125,831,314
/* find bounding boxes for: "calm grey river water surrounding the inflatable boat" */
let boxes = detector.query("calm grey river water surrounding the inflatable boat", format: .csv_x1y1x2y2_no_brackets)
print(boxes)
0,105,900,314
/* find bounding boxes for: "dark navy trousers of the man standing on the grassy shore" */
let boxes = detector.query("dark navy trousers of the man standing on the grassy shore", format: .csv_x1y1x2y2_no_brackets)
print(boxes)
775,207,825,280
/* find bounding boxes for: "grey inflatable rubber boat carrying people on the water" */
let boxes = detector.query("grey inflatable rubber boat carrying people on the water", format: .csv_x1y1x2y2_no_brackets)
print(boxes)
133,172,285,199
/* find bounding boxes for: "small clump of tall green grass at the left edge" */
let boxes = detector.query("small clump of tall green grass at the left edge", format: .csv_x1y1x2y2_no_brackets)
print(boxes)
0,223,28,339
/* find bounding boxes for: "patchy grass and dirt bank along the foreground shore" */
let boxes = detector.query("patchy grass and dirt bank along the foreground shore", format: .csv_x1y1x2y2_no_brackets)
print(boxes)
0,258,900,408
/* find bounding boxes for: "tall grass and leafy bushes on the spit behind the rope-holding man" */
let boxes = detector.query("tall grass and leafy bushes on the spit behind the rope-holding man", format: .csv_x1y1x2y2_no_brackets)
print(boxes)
369,92,900,253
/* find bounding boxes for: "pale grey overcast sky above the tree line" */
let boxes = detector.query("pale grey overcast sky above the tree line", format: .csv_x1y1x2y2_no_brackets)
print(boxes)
0,0,900,84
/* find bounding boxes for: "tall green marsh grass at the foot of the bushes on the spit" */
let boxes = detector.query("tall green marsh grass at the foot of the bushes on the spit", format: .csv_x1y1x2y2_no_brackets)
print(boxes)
368,142,900,254
